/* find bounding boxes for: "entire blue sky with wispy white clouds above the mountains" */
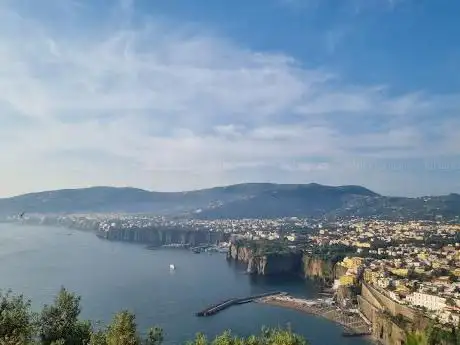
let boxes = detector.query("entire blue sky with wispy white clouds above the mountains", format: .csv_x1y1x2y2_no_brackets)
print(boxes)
0,0,460,197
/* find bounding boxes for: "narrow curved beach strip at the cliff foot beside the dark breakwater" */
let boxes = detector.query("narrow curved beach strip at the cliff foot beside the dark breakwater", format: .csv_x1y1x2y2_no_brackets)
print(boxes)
254,294,371,337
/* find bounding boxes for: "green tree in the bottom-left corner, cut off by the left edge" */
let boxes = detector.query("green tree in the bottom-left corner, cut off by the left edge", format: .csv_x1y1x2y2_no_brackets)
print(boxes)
0,291,35,344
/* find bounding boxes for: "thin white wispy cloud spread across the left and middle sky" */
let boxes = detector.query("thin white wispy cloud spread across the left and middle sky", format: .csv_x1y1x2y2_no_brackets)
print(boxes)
0,1,460,195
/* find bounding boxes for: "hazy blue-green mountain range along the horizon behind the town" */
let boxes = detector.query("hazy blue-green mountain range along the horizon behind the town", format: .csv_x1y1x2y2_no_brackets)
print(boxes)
0,183,460,219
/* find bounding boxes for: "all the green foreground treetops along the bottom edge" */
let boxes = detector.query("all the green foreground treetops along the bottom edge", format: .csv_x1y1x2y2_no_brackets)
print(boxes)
0,288,308,345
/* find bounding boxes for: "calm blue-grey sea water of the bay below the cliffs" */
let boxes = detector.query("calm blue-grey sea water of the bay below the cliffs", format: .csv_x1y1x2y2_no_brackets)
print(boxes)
0,224,369,345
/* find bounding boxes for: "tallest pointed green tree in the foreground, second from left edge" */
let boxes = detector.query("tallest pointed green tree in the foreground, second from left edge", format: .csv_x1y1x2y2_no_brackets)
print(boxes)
38,288,91,345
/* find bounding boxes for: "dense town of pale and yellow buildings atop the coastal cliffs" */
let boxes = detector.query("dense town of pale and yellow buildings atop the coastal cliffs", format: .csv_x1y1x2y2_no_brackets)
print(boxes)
7,214,460,326
